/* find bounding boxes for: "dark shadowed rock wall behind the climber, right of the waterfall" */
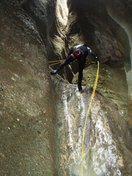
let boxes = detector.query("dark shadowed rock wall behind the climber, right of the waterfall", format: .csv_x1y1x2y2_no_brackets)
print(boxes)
71,0,130,65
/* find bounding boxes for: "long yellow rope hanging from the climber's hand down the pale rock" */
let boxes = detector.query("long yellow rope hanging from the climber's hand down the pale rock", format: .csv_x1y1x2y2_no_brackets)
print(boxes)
80,61,99,176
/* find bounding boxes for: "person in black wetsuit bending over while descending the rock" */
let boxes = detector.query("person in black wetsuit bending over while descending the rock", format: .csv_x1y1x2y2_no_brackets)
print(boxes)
50,44,98,91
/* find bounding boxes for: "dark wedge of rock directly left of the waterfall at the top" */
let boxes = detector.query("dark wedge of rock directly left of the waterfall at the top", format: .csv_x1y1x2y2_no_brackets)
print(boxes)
22,0,55,40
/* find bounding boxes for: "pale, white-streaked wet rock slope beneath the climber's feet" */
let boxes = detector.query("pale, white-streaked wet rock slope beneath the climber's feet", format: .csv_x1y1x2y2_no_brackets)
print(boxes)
55,65,132,176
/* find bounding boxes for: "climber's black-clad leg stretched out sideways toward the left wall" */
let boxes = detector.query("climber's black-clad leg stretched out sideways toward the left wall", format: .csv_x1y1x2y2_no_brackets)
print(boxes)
50,56,75,75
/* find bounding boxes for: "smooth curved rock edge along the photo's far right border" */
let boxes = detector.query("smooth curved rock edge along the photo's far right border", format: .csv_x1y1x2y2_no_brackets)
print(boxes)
106,1,132,119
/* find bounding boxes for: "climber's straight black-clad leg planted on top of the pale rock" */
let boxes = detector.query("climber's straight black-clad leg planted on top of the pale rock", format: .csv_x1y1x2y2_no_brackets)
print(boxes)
78,58,86,91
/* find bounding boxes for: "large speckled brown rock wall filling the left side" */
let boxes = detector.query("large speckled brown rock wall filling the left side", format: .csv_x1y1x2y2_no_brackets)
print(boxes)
0,1,56,176
